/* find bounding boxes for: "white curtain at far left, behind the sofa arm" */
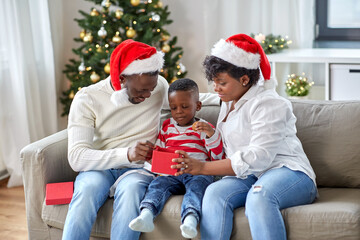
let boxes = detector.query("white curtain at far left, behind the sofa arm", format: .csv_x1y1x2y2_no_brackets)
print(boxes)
0,0,57,187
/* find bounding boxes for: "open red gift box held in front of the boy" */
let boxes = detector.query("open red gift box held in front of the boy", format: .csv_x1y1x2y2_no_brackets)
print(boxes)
151,148,181,175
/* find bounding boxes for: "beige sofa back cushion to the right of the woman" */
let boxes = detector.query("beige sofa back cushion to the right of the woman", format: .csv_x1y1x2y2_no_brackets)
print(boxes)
292,100,360,188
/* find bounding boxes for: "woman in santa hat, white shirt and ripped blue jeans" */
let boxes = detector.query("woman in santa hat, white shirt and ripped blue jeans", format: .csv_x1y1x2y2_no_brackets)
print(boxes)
174,34,317,240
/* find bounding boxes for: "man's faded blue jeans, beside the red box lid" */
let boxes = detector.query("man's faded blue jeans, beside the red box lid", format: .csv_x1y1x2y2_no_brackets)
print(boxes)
62,168,153,240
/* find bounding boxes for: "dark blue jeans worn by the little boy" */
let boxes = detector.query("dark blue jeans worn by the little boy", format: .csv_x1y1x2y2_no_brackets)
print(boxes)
140,174,214,222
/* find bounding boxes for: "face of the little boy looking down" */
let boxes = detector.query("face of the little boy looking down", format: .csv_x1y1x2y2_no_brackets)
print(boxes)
169,90,201,126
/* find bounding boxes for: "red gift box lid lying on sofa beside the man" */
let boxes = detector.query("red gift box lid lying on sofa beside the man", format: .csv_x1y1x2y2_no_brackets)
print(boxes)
45,182,74,205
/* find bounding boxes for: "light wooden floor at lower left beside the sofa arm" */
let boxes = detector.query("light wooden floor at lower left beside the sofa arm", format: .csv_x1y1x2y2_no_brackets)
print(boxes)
0,179,28,240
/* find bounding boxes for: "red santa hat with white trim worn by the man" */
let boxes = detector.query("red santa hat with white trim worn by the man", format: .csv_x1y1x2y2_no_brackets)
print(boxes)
110,39,164,105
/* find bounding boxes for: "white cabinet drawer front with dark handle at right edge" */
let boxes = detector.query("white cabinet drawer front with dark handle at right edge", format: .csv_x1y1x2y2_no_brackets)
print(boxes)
330,64,360,100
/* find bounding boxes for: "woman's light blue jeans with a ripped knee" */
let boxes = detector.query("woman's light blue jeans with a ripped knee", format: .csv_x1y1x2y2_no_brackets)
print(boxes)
200,167,317,240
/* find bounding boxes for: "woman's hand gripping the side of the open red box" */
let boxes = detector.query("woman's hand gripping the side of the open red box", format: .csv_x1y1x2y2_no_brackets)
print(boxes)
171,150,205,176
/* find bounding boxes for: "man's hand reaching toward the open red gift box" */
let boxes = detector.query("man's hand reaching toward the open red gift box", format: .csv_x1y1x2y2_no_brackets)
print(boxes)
128,141,154,162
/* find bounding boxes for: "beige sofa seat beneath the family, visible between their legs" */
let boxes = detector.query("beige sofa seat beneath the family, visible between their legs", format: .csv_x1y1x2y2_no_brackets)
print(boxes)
42,188,360,240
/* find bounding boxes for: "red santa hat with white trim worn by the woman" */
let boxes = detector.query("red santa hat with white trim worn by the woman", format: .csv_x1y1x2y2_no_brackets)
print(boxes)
211,34,276,89
